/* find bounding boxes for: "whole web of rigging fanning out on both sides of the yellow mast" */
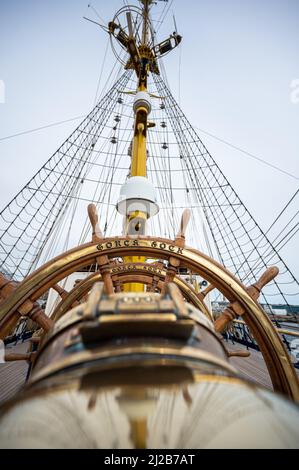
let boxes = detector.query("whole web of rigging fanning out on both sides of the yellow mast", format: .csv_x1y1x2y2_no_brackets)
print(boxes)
0,68,298,316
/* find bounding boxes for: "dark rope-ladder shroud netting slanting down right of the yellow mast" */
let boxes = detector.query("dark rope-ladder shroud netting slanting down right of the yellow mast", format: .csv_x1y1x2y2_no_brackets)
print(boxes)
156,72,298,303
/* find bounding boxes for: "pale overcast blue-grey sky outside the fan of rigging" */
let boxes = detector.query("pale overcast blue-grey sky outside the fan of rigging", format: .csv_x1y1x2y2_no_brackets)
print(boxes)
0,0,299,277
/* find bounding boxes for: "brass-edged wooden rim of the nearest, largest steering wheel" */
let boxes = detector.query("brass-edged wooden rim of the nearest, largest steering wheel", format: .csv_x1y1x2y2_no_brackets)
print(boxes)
0,237,299,400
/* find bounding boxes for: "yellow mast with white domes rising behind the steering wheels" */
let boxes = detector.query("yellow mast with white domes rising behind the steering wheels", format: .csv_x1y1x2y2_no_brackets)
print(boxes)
109,0,182,292
